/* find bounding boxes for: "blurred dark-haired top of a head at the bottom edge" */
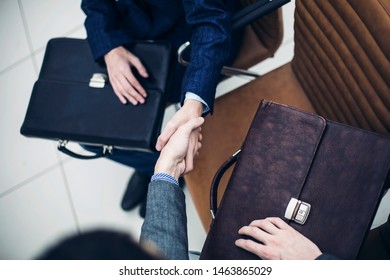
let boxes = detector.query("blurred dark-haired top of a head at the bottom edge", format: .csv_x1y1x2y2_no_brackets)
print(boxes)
38,230,155,260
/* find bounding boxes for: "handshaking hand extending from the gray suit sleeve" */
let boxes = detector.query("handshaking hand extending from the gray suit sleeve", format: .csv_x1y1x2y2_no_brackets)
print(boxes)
155,117,204,179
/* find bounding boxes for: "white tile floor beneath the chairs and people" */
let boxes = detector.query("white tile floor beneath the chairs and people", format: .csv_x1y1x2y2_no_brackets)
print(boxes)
0,0,390,259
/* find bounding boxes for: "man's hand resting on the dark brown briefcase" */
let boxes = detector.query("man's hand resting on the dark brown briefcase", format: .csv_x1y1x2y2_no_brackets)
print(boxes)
236,218,321,260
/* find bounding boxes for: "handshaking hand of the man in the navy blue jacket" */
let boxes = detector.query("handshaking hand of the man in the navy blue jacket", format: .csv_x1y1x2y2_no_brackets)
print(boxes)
156,99,203,151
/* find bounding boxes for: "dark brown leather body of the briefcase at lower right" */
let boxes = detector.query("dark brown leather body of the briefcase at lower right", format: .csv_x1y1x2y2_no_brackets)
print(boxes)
201,101,390,259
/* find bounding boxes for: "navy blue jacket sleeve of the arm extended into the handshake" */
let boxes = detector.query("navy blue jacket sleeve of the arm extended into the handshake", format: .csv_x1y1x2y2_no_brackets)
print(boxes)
181,0,231,113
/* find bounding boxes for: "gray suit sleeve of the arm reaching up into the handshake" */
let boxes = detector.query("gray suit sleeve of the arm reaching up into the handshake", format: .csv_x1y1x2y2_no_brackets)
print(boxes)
140,180,188,260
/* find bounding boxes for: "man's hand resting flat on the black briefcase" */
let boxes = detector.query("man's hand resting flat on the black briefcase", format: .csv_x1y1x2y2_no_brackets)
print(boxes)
104,46,148,105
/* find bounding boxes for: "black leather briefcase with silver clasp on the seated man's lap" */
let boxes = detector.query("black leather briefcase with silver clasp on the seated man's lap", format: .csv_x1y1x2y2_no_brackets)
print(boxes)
21,38,172,158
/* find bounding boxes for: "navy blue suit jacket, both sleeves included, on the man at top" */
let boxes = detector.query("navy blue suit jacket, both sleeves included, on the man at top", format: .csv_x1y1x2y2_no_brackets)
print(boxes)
81,0,234,112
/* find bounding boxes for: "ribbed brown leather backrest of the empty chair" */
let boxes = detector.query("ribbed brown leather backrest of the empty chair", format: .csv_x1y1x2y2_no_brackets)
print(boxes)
292,0,390,134
